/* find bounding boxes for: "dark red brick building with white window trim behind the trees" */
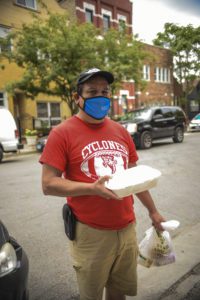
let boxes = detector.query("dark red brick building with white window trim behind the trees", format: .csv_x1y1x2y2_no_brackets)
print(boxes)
76,0,135,115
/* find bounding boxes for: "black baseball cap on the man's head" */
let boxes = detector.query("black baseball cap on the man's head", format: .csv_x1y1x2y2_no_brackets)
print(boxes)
77,68,114,85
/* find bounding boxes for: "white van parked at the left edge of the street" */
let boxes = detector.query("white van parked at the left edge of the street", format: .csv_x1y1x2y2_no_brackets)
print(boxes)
0,108,23,162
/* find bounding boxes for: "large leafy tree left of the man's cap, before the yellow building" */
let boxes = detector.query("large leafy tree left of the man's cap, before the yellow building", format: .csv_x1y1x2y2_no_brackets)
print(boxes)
2,14,100,111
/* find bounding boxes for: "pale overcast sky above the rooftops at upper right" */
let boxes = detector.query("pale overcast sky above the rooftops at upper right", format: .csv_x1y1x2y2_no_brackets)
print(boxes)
132,0,200,44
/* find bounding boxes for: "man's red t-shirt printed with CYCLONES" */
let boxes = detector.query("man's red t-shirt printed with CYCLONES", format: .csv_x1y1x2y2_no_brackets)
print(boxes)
40,116,138,230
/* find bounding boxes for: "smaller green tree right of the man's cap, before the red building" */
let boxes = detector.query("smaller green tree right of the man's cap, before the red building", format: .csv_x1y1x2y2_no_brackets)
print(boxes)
99,29,147,90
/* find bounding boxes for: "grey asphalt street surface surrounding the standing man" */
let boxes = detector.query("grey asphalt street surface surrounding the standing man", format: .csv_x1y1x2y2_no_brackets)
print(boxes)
0,133,200,300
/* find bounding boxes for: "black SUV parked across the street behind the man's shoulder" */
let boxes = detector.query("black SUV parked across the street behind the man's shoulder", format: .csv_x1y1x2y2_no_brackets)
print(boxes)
120,106,187,149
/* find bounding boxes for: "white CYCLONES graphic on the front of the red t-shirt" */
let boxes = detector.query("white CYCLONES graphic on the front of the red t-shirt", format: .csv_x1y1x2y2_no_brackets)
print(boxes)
81,140,128,180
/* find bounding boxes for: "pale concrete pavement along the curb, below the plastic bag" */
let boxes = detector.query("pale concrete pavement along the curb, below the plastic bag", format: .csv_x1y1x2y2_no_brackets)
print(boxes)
127,223,200,300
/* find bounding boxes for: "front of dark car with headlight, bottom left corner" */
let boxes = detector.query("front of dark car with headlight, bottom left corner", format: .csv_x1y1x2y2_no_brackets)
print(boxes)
0,221,29,300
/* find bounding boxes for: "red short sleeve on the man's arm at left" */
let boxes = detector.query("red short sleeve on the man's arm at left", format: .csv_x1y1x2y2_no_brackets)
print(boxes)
39,129,67,172
